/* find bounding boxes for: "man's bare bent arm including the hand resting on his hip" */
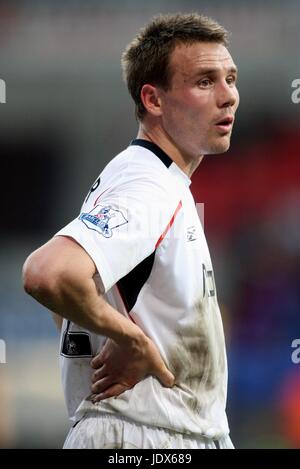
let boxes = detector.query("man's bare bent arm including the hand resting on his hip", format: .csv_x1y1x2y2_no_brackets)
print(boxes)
23,236,174,399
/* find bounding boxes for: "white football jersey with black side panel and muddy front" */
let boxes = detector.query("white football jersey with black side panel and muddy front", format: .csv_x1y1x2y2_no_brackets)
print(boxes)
57,139,229,438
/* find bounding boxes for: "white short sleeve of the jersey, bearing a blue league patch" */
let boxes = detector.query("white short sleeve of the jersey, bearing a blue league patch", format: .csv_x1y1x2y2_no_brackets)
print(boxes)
56,176,180,292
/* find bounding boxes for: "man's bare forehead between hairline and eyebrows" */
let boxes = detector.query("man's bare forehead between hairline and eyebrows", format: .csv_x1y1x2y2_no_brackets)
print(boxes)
170,42,235,76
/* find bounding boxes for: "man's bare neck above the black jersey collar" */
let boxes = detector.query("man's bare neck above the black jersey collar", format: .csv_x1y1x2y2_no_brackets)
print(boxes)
137,121,204,178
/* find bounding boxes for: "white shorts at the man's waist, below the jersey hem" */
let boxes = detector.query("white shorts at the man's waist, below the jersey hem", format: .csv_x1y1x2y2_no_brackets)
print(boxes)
64,412,233,449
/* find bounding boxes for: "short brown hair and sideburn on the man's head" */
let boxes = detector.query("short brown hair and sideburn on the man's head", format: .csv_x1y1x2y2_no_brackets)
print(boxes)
122,13,228,120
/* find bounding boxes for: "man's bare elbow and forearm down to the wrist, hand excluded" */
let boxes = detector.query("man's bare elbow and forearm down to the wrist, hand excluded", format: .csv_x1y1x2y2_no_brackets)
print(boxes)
23,237,146,344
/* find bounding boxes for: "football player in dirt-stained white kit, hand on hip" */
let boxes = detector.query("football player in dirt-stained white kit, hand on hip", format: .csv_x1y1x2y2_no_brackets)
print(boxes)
24,14,239,448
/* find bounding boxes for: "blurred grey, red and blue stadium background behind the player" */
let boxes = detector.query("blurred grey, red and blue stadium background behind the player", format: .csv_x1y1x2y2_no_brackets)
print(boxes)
0,0,300,448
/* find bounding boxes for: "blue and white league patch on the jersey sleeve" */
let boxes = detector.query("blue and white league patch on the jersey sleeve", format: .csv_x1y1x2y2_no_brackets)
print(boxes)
79,205,128,238
